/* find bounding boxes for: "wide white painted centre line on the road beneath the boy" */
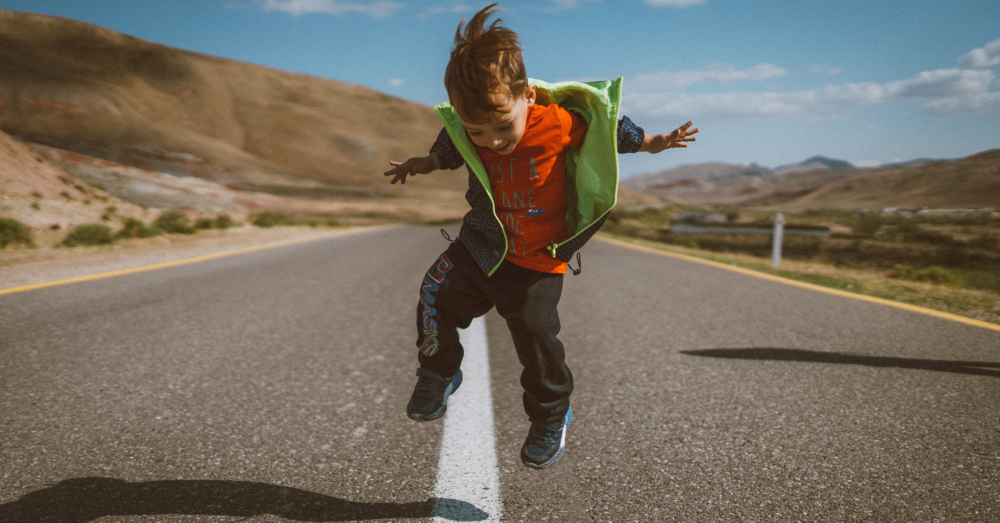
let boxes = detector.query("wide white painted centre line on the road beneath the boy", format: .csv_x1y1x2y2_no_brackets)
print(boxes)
434,317,503,522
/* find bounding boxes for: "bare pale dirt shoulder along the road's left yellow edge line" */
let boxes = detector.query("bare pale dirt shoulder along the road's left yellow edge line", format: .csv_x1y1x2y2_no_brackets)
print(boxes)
0,226,382,292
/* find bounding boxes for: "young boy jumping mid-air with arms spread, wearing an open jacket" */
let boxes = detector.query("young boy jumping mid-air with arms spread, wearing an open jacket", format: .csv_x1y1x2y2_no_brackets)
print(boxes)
385,4,698,468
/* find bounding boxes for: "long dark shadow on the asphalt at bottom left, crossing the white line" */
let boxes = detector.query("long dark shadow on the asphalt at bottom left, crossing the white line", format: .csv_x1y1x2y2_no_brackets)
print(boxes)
0,478,489,523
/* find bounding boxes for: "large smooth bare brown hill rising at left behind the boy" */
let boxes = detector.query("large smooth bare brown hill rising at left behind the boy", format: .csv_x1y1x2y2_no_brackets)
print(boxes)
0,10,465,191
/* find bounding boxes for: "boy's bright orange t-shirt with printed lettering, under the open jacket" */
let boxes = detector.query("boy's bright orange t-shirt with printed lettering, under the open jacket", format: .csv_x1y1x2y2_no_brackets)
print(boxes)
476,104,587,274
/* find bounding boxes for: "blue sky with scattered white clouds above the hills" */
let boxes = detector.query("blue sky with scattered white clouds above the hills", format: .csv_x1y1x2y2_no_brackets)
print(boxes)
0,0,1000,175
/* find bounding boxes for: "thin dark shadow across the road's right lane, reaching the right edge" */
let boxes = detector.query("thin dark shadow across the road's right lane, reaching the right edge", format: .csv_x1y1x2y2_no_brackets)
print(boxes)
681,348,1000,377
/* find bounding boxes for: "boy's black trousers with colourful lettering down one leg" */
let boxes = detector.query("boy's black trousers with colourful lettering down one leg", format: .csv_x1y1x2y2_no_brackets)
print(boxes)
417,241,573,423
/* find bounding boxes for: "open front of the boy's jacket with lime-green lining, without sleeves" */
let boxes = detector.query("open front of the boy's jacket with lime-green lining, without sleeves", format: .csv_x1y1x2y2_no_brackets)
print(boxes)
436,78,622,275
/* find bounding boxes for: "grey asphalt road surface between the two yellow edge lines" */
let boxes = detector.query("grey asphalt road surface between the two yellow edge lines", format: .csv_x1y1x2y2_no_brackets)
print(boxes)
0,227,1000,523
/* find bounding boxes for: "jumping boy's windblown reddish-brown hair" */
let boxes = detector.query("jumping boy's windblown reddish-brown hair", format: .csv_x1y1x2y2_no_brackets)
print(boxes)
444,4,528,124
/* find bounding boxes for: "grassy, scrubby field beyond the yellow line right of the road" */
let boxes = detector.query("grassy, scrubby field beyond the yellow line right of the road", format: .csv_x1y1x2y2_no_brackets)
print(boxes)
602,206,1000,323
